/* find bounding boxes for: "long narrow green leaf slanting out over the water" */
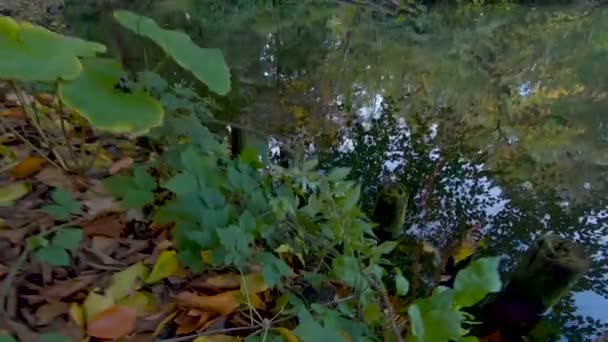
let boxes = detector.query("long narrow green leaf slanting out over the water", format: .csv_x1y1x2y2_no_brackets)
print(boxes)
114,10,230,95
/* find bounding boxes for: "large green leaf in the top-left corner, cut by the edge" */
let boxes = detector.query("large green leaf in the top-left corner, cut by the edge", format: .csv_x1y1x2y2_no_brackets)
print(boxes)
0,17,106,81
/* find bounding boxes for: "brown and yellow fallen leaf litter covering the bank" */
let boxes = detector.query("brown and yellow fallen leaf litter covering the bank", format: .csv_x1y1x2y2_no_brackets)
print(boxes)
0,87,314,342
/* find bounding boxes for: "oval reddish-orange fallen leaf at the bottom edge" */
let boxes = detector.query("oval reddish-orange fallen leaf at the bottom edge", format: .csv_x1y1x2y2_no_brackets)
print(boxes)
87,305,136,339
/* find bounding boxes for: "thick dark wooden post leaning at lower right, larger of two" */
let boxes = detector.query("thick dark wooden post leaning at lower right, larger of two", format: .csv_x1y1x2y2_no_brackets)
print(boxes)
471,235,590,341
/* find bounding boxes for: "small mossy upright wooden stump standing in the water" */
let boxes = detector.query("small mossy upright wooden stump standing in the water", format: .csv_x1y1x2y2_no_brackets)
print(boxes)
372,182,408,241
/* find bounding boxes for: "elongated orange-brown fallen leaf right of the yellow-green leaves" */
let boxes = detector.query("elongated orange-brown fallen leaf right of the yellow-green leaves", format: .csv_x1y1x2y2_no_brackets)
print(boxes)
175,290,241,315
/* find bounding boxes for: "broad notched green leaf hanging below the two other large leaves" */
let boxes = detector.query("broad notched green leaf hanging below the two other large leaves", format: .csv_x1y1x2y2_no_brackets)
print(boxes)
59,58,164,134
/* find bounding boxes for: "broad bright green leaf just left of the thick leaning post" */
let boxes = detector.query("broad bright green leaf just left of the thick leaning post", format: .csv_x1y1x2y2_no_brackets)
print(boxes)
454,257,502,307
